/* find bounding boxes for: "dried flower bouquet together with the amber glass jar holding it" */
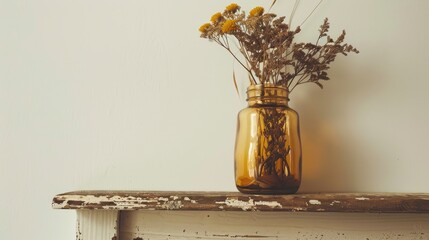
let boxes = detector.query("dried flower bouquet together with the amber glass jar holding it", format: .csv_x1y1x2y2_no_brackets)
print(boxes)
199,0,359,194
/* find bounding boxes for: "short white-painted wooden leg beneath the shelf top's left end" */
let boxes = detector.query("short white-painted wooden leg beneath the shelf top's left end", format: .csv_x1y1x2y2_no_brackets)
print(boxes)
76,209,119,240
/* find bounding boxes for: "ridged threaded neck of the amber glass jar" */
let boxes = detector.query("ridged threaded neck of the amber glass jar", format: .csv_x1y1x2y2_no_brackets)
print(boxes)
247,84,289,107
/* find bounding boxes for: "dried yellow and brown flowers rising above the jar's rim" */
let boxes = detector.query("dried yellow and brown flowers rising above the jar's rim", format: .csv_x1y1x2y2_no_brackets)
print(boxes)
199,1,359,92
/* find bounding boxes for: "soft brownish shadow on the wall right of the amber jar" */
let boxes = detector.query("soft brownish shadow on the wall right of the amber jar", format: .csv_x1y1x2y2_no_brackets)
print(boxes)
291,55,382,192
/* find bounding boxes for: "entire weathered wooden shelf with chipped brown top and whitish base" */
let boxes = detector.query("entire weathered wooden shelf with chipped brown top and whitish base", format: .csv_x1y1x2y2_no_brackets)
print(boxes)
52,191,429,240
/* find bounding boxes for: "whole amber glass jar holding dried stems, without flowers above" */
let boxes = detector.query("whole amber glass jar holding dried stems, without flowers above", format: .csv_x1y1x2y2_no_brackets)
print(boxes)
235,84,302,194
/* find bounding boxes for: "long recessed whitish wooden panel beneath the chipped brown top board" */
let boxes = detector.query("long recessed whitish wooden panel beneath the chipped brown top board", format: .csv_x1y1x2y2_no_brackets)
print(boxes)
119,211,429,240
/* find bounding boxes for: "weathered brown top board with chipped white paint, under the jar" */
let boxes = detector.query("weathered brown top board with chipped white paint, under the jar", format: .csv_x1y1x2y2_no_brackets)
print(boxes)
52,191,429,213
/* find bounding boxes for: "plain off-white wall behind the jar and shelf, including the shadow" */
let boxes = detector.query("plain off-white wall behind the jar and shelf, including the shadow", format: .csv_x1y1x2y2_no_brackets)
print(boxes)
0,0,429,240
